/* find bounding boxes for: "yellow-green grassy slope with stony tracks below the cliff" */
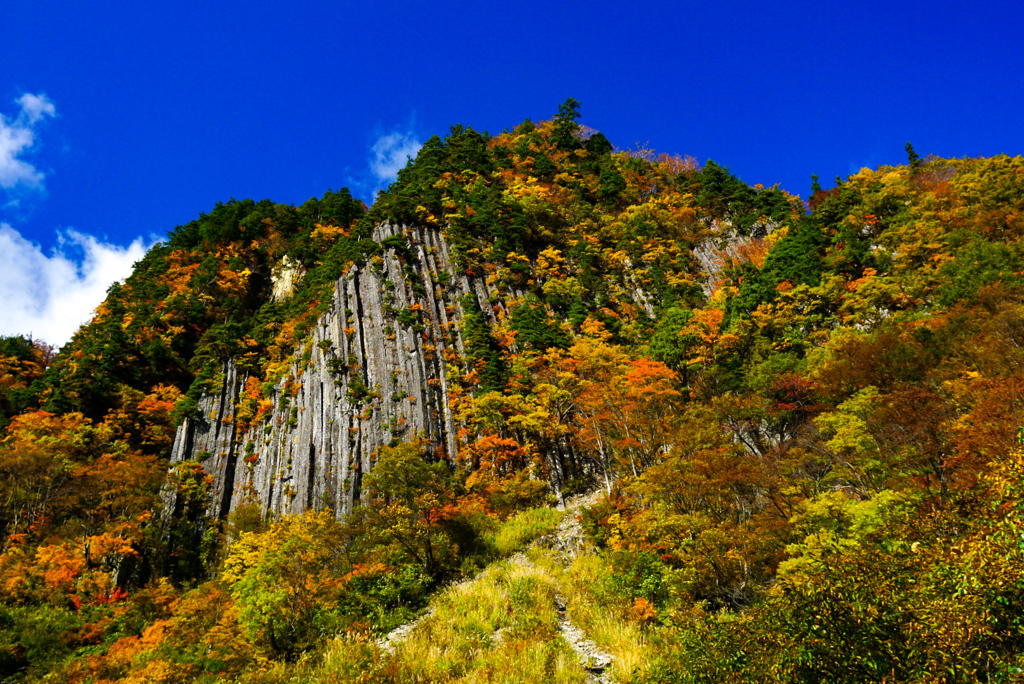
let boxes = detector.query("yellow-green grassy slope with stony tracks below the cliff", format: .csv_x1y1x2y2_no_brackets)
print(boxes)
237,497,645,684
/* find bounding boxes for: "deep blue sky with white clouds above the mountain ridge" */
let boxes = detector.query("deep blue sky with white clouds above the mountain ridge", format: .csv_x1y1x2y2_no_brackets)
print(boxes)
0,0,1024,343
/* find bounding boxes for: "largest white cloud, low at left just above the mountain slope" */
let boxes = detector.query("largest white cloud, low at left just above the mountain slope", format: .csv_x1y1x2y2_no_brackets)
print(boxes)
0,223,150,347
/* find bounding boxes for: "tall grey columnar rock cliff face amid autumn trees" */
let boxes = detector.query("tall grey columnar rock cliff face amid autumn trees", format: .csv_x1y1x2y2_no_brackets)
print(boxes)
165,224,536,517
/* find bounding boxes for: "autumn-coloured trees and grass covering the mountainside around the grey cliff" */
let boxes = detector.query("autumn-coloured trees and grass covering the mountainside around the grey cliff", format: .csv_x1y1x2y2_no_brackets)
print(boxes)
0,99,1024,684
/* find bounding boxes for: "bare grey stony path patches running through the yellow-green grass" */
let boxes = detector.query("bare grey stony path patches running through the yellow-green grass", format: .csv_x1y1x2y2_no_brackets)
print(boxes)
377,489,613,684
